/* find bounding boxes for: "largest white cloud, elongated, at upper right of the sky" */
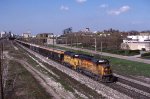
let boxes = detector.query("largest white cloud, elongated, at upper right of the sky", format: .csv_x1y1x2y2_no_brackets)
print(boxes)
108,5,130,15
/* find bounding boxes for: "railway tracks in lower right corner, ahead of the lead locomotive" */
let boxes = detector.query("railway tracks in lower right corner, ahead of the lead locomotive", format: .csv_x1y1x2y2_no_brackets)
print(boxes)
77,69,150,99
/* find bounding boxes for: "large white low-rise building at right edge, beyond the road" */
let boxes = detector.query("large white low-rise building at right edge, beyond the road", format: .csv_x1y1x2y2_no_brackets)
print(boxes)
121,35,150,51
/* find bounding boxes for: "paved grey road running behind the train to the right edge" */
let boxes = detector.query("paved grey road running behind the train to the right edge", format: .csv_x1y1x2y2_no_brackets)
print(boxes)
56,44,150,64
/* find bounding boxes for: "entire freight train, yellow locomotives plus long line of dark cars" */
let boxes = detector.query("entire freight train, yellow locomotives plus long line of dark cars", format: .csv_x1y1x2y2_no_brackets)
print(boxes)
16,40,114,82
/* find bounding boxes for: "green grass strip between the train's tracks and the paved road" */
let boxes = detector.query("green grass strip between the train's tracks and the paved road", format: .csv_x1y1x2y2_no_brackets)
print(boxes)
47,46,150,77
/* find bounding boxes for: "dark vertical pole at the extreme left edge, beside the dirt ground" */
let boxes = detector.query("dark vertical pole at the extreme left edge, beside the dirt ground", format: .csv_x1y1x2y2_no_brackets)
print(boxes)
0,42,4,99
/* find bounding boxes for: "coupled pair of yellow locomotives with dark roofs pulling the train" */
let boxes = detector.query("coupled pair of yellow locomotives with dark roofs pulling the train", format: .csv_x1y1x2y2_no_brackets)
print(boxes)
63,51,113,82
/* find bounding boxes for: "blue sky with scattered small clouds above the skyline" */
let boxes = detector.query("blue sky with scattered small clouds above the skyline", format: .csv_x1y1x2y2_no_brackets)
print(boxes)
0,0,150,34
